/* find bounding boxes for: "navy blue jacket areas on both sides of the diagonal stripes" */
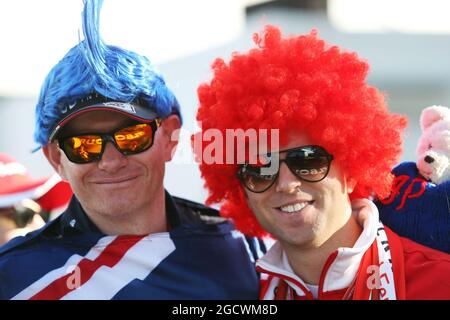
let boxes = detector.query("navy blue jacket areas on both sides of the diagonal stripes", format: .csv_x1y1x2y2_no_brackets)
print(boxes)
0,222,259,299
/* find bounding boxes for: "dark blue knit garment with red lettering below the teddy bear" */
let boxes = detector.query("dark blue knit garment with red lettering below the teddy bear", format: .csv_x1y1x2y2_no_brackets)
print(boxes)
375,162,450,253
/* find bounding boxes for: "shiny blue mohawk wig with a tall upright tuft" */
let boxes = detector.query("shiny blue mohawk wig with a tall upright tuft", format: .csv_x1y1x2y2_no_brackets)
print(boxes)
34,0,181,146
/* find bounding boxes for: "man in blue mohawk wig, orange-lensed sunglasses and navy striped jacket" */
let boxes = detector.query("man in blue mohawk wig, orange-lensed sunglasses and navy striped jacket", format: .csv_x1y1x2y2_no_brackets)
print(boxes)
0,0,264,299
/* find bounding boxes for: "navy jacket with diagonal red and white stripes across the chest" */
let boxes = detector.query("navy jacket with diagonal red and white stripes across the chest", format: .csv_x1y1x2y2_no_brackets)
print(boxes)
0,193,265,299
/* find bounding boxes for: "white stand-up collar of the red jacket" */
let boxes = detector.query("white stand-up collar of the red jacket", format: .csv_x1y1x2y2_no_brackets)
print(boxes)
256,199,379,295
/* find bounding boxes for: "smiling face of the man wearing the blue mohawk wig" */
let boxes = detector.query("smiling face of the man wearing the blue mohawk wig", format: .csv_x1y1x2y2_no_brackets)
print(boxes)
44,111,179,230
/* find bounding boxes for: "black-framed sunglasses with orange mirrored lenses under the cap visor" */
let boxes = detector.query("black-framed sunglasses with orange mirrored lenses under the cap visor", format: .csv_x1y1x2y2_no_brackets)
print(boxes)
57,118,161,164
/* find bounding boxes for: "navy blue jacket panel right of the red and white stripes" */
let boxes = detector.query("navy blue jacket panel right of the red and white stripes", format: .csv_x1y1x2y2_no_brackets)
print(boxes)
114,224,259,300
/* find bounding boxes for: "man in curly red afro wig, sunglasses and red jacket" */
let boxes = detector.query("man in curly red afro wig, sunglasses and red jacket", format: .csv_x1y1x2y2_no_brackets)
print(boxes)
194,26,450,299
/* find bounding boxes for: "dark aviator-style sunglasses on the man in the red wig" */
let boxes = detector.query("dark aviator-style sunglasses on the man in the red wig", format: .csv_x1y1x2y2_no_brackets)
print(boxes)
238,145,333,193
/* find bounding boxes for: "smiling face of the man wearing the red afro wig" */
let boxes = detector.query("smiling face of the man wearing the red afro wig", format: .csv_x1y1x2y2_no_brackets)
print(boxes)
246,136,354,248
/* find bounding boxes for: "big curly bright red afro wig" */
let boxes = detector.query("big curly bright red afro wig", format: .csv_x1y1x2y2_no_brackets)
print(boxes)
194,26,407,236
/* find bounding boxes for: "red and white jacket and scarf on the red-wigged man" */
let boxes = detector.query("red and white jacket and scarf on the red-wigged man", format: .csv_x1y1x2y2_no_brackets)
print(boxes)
257,201,450,300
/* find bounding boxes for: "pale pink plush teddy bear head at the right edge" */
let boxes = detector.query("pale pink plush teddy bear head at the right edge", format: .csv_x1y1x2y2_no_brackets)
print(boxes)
417,106,450,184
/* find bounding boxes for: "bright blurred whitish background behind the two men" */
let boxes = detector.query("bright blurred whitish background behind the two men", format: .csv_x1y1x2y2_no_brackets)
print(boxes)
0,0,450,202
